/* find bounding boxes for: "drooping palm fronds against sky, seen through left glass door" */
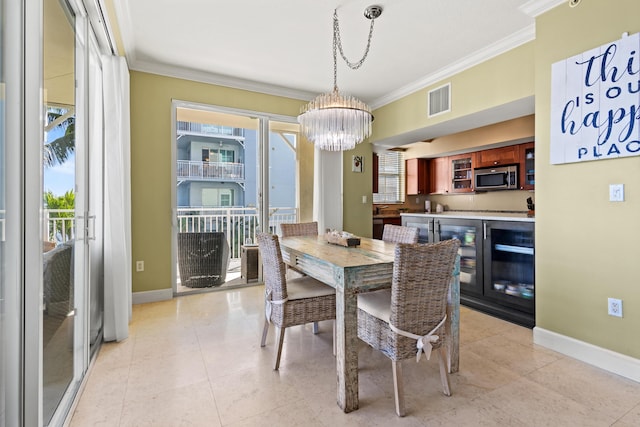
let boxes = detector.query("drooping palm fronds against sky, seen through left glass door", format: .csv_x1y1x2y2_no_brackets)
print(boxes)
42,107,76,167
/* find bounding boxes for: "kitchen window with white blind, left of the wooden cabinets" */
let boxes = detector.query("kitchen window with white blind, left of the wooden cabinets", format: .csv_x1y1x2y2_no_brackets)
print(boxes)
373,151,404,203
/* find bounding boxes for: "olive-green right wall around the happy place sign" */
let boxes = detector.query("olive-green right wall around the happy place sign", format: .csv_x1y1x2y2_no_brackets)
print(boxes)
535,0,640,358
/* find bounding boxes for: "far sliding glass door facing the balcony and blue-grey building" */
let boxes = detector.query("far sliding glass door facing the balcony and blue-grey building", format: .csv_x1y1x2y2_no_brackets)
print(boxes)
174,102,299,293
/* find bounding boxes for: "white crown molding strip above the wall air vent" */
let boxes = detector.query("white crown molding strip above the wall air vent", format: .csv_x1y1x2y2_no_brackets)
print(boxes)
370,24,536,110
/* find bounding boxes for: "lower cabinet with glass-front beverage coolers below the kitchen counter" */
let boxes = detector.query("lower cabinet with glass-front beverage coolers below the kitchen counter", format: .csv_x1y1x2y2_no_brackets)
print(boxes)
402,215,535,327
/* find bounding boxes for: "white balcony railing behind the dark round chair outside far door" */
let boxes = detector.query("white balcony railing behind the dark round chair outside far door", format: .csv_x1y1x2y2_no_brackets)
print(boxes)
178,207,298,258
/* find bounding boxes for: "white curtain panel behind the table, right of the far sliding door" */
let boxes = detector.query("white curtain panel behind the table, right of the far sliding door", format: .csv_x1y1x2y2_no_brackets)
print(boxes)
313,148,342,233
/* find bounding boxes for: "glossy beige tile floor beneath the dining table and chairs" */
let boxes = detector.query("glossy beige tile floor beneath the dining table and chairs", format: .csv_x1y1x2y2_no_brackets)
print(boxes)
71,286,640,427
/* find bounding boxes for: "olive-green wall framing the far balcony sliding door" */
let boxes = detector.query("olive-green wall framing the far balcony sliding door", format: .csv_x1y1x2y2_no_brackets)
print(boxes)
130,71,313,292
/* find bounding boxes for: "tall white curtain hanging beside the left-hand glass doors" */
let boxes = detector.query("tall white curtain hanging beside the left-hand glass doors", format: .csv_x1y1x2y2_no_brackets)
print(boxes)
102,56,131,341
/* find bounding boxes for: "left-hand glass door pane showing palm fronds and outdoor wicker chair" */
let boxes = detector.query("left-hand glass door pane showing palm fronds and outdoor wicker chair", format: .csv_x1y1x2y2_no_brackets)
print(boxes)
42,0,81,425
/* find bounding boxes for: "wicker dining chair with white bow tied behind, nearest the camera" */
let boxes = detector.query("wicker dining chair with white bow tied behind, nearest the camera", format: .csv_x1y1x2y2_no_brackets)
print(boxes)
358,239,460,417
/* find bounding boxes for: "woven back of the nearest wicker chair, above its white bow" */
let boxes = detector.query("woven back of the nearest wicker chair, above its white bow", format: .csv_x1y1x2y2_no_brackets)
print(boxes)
390,239,460,335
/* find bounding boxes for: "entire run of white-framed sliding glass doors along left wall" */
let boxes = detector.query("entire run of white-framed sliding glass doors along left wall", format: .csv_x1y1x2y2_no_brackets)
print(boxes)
0,0,103,427
